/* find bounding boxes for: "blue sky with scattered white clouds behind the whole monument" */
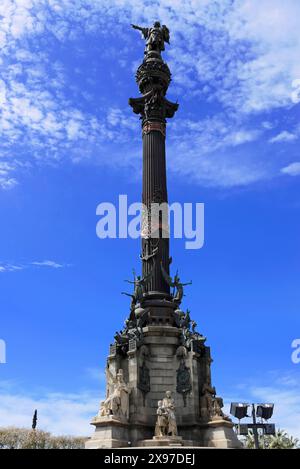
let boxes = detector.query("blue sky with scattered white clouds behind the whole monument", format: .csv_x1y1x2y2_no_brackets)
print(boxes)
0,0,300,436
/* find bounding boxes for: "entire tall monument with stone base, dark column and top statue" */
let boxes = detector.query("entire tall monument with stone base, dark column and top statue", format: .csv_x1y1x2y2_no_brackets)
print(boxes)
86,22,240,449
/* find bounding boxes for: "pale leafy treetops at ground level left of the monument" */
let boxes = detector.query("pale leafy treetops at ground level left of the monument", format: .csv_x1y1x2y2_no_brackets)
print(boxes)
0,427,87,449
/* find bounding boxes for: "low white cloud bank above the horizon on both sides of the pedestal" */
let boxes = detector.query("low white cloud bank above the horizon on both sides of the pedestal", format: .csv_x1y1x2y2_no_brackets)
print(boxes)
0,370,300,438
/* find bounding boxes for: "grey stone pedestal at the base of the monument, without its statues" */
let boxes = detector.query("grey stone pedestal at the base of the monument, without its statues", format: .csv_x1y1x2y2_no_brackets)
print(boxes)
86,325,240,449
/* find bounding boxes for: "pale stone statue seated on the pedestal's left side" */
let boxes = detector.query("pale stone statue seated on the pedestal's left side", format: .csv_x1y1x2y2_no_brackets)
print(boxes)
98,370,130,420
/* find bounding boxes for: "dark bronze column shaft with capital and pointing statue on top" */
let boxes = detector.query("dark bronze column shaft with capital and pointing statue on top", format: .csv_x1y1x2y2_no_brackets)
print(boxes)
129,22,178,298
